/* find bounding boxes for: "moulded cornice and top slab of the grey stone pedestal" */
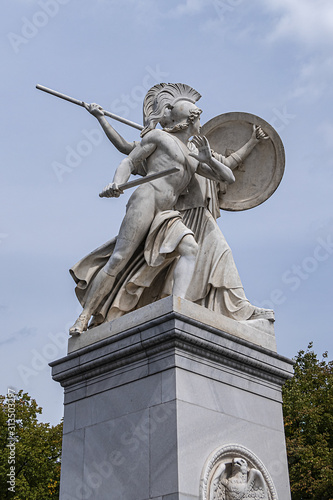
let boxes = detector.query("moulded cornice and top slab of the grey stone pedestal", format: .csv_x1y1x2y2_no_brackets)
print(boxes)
50,297,292,386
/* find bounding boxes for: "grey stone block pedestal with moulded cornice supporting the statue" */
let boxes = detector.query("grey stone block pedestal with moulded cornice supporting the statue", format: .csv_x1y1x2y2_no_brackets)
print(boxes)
51,297,292,500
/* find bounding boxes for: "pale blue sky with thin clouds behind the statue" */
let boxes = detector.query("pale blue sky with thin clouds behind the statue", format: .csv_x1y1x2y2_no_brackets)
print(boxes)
0,0,333,423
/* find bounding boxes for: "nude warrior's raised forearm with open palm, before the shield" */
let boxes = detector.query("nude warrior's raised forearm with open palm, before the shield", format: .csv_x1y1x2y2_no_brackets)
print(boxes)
189,136,235,184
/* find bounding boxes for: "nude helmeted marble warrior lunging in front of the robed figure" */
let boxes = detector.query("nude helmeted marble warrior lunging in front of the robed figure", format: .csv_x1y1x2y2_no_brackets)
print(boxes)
70,84,235,335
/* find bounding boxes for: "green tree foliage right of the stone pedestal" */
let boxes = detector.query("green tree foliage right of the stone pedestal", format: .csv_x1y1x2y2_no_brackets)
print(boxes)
283,343,333,500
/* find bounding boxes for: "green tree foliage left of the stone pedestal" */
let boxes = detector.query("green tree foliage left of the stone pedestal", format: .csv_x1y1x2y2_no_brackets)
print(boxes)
0,391,62,500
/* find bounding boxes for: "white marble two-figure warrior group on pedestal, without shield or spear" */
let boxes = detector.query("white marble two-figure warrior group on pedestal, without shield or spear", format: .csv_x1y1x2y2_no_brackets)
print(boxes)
65,84,274,335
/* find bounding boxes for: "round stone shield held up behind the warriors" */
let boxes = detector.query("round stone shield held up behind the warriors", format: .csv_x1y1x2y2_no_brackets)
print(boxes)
201,112,285,211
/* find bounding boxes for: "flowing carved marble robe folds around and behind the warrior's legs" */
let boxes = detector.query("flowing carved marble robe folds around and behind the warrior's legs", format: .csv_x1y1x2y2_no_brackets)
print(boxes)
70,175,254,327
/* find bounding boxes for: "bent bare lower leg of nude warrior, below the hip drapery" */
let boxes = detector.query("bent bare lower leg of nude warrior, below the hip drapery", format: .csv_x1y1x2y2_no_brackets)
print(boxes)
172,234,198,299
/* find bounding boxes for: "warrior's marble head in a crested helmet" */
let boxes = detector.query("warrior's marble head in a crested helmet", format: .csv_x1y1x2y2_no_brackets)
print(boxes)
141,83,201,136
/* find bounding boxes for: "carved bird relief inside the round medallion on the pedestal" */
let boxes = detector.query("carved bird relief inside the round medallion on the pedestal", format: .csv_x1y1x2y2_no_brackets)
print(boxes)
209,457,269,500
